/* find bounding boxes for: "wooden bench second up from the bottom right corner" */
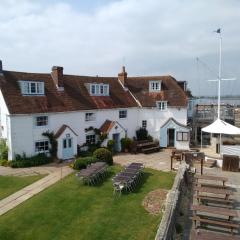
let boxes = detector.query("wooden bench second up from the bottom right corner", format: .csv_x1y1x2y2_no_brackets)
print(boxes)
192,216,239,234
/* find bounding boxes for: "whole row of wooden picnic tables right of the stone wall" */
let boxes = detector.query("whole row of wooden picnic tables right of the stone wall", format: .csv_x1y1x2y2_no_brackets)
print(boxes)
191,174,240,240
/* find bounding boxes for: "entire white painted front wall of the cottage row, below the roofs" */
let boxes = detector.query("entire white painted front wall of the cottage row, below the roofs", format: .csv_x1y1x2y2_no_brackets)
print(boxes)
8,108,187,159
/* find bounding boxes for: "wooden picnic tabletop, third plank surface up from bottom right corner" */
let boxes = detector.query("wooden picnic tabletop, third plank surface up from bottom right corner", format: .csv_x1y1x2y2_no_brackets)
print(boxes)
191,205,238,220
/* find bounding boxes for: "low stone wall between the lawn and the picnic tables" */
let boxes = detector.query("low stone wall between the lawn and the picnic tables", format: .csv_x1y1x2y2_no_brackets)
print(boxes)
155,163,188,240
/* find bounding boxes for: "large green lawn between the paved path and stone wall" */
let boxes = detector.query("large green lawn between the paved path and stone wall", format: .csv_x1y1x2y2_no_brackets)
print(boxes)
0,166,175,240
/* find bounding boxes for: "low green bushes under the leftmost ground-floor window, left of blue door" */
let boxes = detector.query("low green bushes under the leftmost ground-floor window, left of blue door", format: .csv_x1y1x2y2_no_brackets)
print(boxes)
10,153,52,168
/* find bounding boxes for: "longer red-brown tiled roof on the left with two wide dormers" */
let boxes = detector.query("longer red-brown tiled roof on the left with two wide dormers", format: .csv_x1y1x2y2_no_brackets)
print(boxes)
0,71,138,114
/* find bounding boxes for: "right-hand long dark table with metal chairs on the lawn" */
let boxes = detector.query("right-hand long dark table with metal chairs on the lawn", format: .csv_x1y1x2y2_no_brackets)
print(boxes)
112,163,144,195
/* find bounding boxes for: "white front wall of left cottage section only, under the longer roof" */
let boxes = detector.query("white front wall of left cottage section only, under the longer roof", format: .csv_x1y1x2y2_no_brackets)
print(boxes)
9,108,138,159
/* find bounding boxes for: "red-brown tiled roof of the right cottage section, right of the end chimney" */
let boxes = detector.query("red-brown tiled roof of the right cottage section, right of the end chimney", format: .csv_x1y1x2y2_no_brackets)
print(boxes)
125,76,187,107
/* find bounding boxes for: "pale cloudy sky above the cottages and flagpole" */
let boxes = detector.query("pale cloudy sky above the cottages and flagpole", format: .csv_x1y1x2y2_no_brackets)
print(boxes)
0,0,240,95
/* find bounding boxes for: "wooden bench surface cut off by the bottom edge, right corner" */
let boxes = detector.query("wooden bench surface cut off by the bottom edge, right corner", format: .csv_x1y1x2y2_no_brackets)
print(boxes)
191,231,240,240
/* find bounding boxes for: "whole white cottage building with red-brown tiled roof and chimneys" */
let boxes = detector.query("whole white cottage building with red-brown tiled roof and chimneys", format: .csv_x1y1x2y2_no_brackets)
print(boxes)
0,61,189,160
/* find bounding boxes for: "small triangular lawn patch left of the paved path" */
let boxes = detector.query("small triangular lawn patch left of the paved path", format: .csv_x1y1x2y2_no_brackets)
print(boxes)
0,175,43,200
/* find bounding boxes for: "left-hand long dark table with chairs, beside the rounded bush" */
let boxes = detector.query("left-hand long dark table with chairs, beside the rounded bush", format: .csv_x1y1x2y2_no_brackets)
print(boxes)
76,162,108,185
